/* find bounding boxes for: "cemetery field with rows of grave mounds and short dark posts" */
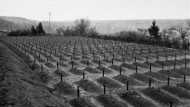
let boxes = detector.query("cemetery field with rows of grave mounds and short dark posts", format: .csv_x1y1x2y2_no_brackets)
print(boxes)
0,36,190,107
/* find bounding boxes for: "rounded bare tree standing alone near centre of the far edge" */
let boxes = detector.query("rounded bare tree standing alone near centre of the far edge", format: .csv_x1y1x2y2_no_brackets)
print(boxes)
74,18,90,36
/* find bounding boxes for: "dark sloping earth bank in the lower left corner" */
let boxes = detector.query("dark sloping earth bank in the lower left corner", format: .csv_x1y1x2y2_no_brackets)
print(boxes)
0,42,67,107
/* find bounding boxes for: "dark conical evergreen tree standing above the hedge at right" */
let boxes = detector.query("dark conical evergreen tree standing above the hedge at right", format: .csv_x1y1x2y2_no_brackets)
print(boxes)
148,20,160,39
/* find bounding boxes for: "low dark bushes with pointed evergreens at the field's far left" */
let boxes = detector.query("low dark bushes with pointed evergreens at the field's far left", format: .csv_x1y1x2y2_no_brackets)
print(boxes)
8,22,46,36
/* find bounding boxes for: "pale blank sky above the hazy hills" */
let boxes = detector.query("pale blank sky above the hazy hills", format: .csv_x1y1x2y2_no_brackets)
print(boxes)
0,0,190,21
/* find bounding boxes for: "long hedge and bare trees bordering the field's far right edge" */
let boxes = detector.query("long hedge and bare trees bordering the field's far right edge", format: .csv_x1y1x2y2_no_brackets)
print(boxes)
57,18,190,49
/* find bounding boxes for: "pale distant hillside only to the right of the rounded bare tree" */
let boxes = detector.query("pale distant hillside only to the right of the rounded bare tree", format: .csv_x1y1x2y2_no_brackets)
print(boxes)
92,20,186,33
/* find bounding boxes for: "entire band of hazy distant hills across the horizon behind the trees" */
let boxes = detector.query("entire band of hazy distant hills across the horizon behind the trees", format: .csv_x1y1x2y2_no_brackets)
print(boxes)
0,16,186,33
